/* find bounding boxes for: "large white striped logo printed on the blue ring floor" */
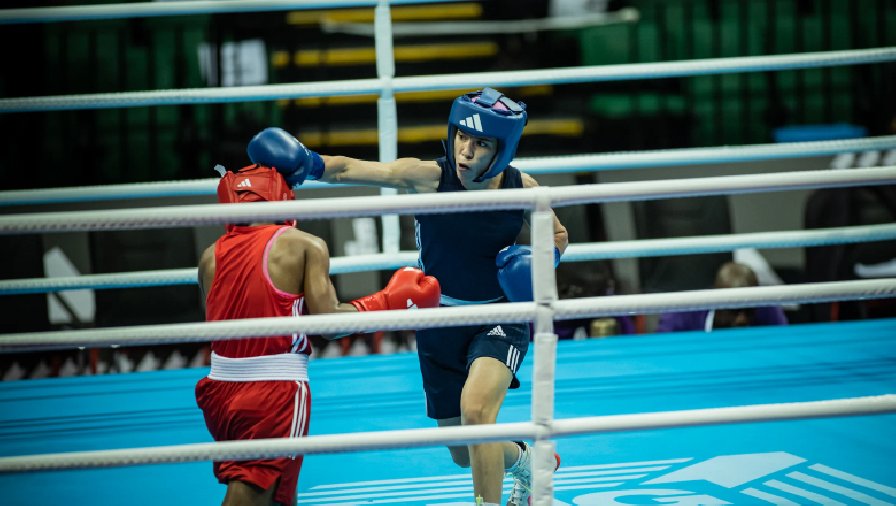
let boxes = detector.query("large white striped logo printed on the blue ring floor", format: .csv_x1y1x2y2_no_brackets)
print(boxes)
299,452,896,506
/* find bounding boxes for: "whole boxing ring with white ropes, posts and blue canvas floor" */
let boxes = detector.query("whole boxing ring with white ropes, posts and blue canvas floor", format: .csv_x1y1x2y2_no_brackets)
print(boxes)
0,1,896,506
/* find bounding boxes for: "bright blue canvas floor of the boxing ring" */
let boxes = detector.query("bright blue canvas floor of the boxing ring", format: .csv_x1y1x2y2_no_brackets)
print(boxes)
0,319,896,506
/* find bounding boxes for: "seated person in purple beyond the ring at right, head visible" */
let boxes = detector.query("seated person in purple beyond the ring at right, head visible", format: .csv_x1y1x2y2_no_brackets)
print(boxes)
656,262,787,332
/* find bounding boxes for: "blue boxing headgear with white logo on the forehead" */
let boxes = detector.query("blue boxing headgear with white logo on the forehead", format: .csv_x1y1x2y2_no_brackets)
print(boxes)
445,88,528,183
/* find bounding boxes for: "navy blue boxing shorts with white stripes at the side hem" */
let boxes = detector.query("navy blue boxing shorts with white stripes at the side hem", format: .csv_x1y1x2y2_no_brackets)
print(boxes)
417,323,529,420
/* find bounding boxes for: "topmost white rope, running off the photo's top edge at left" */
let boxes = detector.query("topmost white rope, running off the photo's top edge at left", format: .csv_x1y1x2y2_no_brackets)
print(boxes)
0,0,448,25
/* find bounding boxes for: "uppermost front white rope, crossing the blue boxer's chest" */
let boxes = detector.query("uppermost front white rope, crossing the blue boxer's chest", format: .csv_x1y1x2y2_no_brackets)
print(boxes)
0,166,896,235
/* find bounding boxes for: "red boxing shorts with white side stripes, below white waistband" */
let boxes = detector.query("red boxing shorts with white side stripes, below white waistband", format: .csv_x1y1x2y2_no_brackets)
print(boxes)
196,378,311,504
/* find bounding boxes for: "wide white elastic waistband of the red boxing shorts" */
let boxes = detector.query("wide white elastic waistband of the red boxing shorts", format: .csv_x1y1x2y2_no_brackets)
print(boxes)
208,353,308,381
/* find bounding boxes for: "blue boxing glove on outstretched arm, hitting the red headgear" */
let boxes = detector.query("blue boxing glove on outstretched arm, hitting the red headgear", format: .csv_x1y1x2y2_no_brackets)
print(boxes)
246,127,324,188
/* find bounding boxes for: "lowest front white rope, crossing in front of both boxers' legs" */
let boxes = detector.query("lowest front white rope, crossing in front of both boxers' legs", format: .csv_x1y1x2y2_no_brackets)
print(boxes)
0,394,896,473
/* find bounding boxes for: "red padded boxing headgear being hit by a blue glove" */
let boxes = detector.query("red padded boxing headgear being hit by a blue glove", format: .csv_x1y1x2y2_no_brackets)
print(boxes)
218,165,296,230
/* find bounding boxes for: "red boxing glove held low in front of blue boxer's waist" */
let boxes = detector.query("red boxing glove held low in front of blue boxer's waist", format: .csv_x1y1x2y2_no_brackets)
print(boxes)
352,267,442,311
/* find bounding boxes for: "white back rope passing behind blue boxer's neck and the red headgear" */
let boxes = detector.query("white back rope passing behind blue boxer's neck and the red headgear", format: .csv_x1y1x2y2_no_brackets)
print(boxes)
0,135,896,207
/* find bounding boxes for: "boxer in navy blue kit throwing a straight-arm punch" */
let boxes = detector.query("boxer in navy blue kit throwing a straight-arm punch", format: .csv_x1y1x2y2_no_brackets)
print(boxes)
249,88,569,506
